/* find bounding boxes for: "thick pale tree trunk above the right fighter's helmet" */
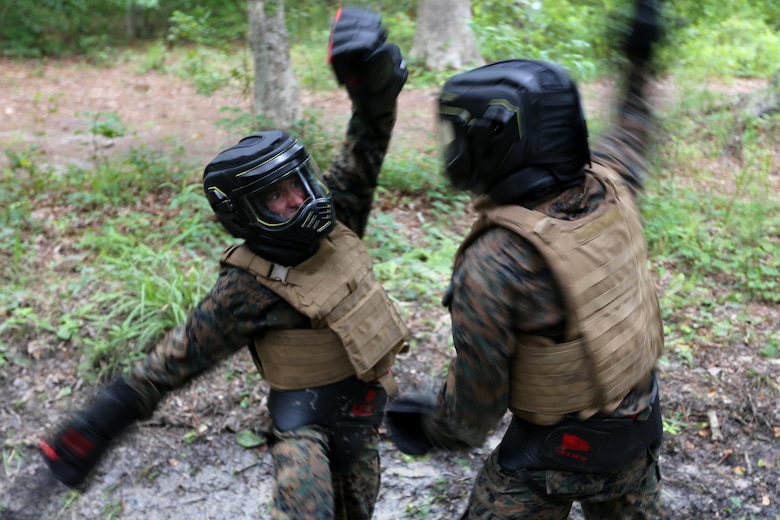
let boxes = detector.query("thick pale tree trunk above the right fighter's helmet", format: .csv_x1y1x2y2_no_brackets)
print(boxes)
409,0,484,71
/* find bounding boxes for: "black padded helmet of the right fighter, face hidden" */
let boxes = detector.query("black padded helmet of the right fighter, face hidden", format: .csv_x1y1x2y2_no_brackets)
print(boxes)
439,60,590,203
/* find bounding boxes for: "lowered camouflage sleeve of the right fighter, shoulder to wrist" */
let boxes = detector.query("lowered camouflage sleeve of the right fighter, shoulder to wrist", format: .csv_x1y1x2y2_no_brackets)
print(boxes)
427,228,564,449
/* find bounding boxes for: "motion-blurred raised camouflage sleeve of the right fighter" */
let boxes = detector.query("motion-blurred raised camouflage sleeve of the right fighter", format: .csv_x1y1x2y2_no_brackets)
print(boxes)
593,68,654,192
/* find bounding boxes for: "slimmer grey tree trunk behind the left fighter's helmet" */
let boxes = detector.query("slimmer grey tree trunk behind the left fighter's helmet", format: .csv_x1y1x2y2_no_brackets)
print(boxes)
247,0,303,130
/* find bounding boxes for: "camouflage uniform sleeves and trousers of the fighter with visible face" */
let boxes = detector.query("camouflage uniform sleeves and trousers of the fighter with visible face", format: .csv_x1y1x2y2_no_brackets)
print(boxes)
127,111,402,519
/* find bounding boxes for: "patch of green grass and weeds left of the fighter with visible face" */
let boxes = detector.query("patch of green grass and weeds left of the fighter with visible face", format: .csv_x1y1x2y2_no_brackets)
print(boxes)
0,116,213,377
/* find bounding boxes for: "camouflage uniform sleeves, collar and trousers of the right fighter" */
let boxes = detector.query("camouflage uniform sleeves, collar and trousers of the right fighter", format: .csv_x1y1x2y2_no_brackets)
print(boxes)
444,84,664,519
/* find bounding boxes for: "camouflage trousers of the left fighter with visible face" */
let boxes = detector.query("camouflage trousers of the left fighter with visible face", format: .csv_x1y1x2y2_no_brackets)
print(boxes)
270,426,380,520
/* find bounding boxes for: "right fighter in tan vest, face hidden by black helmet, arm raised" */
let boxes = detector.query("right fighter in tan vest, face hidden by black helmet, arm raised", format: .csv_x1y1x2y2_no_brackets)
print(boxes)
386,0,665,520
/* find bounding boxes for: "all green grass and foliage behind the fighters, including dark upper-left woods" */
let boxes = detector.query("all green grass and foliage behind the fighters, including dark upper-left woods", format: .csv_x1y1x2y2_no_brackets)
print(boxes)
0,0,780,377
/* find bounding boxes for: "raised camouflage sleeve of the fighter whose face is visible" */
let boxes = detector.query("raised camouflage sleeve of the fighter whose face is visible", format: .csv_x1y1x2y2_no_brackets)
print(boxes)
325,110,396,237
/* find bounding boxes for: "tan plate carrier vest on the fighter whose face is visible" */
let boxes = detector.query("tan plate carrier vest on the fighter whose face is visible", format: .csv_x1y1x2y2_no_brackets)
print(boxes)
220,223,407,395
